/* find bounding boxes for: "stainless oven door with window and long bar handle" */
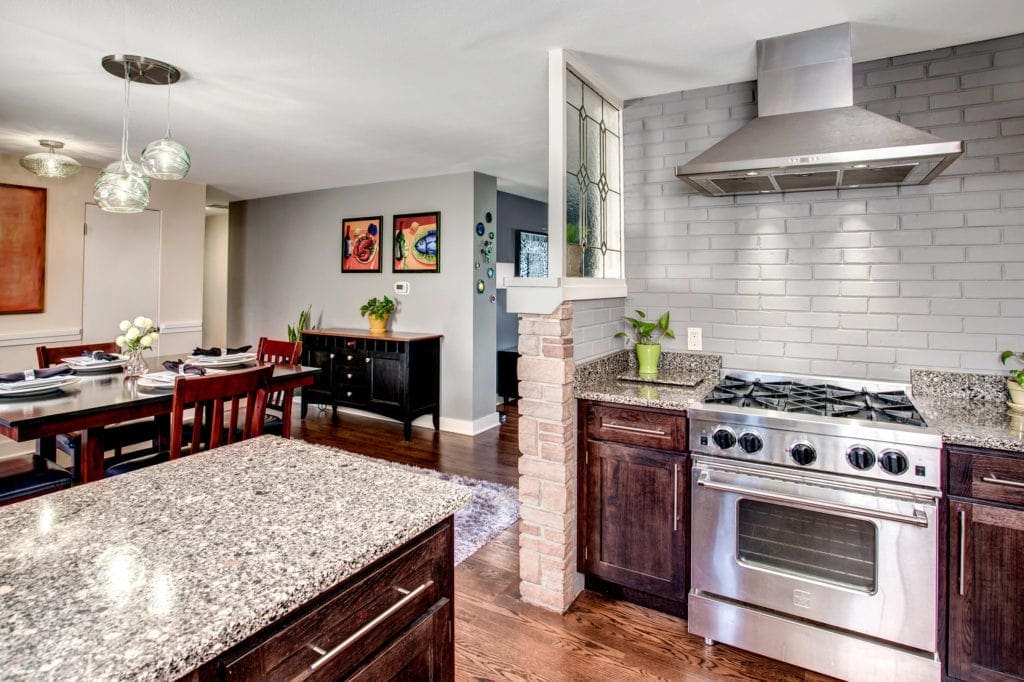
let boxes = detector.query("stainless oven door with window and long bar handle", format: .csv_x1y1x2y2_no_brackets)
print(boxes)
691,456,940,652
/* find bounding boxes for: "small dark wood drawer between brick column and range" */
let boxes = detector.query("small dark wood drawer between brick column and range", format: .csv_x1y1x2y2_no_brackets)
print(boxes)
587,404,687,452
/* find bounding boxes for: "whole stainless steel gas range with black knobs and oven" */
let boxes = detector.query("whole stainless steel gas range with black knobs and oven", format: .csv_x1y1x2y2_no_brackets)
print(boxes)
688,373,941,682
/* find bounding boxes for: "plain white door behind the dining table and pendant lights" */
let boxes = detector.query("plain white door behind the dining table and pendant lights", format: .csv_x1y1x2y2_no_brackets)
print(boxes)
82,204,161,350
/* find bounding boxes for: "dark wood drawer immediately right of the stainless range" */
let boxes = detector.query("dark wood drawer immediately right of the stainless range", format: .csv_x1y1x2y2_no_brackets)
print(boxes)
948,447,1024,506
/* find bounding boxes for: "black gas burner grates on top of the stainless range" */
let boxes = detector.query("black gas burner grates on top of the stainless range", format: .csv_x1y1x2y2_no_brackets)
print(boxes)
703,375,928,427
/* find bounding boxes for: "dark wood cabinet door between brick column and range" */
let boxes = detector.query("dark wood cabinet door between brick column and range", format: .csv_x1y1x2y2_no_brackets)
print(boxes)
585,440,688,600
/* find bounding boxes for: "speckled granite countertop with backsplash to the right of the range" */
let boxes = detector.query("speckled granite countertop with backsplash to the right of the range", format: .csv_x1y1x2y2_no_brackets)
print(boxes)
910,370,1024,454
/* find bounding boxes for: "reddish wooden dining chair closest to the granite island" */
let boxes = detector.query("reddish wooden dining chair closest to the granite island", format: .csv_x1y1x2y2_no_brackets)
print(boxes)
106,365,273,476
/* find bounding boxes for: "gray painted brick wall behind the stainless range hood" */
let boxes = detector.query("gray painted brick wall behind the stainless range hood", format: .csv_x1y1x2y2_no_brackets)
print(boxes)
624,35,1024,380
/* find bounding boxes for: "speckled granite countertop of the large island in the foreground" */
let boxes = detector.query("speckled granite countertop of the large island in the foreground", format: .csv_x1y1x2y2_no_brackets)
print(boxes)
0,436,472,680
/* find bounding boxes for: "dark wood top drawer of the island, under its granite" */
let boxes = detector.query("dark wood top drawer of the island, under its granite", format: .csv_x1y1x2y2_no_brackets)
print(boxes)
224,520,451,680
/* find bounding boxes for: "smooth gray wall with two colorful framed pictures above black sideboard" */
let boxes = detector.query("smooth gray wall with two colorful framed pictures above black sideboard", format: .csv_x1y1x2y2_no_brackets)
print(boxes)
227,172,496,427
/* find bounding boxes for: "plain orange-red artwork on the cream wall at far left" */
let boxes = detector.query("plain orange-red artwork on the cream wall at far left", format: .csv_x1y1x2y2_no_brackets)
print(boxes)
0,184,46,314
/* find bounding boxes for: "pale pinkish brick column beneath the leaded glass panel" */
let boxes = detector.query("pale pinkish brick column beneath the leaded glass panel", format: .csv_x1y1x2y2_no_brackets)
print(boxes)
519,301,583,612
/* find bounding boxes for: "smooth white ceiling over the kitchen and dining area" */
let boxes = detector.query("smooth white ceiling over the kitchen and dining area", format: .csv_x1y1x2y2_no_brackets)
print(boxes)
0,0,1024,199
